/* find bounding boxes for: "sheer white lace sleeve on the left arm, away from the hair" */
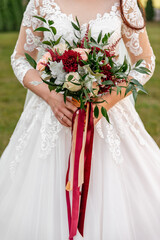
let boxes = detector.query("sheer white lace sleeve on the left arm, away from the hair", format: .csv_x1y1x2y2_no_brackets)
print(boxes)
11,0,43,86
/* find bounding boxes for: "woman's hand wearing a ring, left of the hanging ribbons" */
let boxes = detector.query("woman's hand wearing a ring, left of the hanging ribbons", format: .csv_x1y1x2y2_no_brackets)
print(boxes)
47,90,77,127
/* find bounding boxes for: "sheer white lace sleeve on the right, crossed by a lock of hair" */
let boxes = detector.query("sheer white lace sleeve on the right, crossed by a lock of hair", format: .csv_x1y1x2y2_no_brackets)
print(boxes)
122,0,155,85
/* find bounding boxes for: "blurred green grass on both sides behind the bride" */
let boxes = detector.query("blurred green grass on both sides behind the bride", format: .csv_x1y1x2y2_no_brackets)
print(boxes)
0,23,160,155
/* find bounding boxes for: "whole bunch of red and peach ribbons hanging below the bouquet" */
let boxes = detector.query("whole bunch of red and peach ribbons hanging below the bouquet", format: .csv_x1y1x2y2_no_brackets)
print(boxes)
66,102,94,240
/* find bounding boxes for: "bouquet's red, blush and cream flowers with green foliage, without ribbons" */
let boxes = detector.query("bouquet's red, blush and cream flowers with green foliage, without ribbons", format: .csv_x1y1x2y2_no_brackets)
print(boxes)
26,16,149,121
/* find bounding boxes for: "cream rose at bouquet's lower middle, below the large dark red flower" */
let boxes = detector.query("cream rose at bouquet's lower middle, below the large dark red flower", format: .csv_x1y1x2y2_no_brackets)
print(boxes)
63,72,82,92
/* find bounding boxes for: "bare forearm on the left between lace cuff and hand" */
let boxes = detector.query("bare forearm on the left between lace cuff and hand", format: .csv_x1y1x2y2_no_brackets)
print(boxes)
23,69,50,102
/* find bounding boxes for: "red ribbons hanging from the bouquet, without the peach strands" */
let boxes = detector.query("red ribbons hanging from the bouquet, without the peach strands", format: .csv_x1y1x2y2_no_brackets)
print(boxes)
66,103,94,240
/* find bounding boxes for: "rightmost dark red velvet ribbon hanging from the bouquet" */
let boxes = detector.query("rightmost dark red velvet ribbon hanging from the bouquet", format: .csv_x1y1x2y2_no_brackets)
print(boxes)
78,103,94,236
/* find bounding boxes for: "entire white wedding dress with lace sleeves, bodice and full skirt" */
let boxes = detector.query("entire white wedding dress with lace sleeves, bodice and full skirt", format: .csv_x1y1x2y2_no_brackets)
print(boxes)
0,0,160,240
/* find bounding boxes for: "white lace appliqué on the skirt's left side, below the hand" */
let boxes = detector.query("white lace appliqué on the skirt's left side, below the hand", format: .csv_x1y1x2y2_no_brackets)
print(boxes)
9,95,65,180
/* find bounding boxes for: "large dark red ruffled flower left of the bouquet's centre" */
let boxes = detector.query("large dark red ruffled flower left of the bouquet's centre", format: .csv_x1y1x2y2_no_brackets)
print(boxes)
62,50,82,72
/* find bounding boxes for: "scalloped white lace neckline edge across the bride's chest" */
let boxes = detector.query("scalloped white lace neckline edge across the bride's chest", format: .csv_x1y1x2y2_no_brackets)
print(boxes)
54,1,119,28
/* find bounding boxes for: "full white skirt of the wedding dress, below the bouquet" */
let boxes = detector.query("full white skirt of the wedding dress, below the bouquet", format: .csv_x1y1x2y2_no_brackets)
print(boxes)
0,95,160,240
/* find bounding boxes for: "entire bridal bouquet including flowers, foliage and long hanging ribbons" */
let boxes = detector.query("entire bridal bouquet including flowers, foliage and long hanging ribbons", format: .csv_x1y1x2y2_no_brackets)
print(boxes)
26,16,149,239
